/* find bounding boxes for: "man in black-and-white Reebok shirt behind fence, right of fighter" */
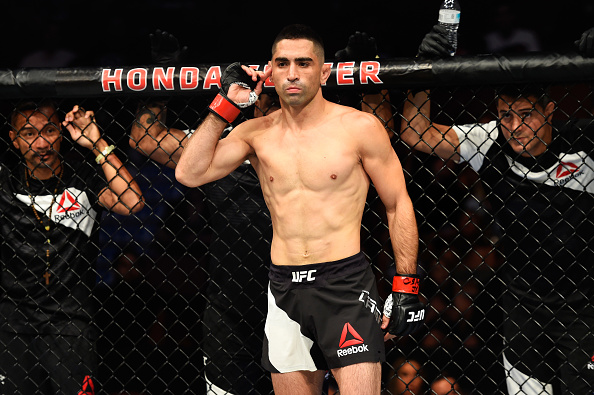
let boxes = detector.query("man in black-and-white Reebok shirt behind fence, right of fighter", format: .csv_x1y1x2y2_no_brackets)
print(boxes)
401,26,594,394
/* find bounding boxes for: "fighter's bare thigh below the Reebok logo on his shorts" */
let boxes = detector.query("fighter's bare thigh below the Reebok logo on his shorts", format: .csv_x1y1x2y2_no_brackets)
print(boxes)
332,362,382,395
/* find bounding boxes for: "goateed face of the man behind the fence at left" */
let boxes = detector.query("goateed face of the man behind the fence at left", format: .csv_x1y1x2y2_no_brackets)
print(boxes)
10,107,62,171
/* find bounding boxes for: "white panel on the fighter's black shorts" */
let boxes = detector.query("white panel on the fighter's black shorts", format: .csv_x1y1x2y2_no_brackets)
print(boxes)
264,284,318,373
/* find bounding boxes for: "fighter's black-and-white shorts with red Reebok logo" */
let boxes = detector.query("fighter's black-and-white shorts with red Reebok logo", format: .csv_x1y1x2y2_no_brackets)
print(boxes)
262,252,385,373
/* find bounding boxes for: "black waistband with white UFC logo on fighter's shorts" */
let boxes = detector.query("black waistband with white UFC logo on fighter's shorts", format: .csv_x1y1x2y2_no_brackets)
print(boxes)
268,251,369,283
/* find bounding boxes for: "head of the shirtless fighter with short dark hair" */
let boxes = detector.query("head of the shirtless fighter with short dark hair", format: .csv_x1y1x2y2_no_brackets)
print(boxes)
271,39,330,106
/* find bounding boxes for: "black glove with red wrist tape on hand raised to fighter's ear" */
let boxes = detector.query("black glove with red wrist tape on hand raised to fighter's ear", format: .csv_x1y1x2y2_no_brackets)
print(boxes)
208,62,258,123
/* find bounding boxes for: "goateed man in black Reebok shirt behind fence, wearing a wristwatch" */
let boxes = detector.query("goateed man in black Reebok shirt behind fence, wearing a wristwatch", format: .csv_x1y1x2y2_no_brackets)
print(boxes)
0,101,143,394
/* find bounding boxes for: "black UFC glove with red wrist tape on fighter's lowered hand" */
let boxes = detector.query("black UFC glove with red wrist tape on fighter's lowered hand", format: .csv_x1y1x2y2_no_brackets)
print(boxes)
384,274,425,336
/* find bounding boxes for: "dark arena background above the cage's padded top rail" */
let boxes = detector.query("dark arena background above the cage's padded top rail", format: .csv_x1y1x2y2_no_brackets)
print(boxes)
0,0,594,68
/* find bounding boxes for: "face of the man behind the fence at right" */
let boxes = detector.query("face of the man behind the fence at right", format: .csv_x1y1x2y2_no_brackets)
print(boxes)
497,95,555,156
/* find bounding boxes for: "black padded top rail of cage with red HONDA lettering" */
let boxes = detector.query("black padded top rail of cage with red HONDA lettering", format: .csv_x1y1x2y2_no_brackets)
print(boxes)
0,53,594,98
